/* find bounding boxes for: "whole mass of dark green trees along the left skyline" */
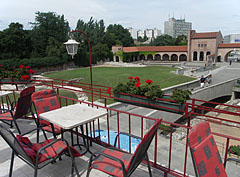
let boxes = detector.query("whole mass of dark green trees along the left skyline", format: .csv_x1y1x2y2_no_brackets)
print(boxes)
0,12,134,66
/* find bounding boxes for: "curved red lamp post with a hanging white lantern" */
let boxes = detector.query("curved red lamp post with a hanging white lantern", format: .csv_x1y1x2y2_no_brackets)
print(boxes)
64,30,93,106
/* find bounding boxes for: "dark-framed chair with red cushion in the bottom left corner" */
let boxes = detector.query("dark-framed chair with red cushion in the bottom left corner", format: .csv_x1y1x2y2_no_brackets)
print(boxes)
0,125,81,177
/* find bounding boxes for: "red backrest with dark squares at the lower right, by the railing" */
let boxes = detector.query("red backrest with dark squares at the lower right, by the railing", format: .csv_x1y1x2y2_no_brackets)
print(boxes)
188,121,227,177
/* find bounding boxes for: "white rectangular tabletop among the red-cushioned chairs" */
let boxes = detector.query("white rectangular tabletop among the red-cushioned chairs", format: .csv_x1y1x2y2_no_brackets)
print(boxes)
39,104,107,129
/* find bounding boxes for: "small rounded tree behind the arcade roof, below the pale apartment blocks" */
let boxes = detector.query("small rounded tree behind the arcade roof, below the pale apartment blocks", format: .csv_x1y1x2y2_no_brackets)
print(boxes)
151,34,175,46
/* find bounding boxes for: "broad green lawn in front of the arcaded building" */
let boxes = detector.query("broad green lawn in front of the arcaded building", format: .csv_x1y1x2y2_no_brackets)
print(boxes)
44,66,194,88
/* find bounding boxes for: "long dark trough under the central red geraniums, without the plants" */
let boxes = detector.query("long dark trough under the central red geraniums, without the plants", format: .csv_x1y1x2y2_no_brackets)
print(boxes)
114,93,186,114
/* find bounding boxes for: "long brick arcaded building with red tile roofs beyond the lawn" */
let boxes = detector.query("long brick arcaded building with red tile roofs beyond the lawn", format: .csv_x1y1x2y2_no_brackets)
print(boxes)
112,30,240,63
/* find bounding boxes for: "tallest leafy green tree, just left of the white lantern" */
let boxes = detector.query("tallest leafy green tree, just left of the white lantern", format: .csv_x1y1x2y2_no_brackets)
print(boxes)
31,12,70,57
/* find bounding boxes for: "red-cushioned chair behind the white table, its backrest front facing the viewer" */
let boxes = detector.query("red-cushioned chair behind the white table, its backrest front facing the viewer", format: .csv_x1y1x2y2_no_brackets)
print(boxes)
32,89,62,141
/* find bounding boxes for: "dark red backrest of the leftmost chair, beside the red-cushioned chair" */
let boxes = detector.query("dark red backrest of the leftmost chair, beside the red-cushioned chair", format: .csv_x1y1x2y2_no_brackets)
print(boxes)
14,86,35,119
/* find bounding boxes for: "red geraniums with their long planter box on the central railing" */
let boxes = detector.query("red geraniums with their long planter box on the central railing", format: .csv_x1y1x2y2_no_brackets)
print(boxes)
112,77,190,113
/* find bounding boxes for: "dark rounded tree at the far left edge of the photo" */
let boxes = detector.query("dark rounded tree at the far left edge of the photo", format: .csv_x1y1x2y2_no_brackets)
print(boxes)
0,23,31,59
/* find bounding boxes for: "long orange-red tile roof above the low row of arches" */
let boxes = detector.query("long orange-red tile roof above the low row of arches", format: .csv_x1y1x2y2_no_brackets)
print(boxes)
123,46,187,53
